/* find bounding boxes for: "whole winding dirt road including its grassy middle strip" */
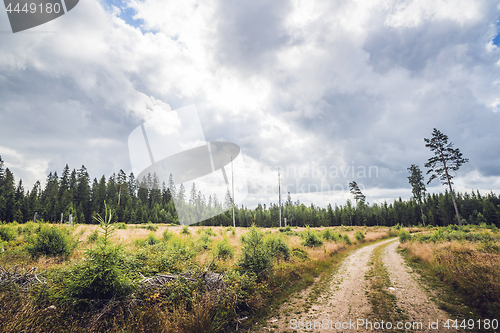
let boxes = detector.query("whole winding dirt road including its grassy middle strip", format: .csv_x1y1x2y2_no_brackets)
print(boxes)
259,239,457,332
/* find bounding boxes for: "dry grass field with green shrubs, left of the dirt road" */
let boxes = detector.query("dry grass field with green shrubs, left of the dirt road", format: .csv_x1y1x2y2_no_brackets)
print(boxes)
0,223,394,332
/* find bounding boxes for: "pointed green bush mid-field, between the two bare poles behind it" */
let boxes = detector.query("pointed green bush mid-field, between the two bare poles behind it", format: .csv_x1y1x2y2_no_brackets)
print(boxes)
238,225,273,276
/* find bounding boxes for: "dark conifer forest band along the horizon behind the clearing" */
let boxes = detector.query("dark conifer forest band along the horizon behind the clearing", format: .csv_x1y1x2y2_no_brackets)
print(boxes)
0,154,500,227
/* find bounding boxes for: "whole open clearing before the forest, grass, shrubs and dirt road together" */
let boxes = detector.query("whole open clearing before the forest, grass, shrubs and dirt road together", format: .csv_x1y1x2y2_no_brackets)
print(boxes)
0,217,500,332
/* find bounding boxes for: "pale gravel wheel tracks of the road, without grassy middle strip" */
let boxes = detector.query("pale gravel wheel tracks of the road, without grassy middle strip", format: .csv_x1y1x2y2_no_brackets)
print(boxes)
260,239,458,332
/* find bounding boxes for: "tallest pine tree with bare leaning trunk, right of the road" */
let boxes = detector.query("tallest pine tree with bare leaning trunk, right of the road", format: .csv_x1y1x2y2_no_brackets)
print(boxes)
424,128,469,225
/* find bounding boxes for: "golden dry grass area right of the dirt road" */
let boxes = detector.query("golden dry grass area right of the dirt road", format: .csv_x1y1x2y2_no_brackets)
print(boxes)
400,228,500,318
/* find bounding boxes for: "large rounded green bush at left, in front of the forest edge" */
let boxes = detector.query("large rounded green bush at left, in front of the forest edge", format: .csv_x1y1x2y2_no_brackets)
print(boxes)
26,225,76,258
